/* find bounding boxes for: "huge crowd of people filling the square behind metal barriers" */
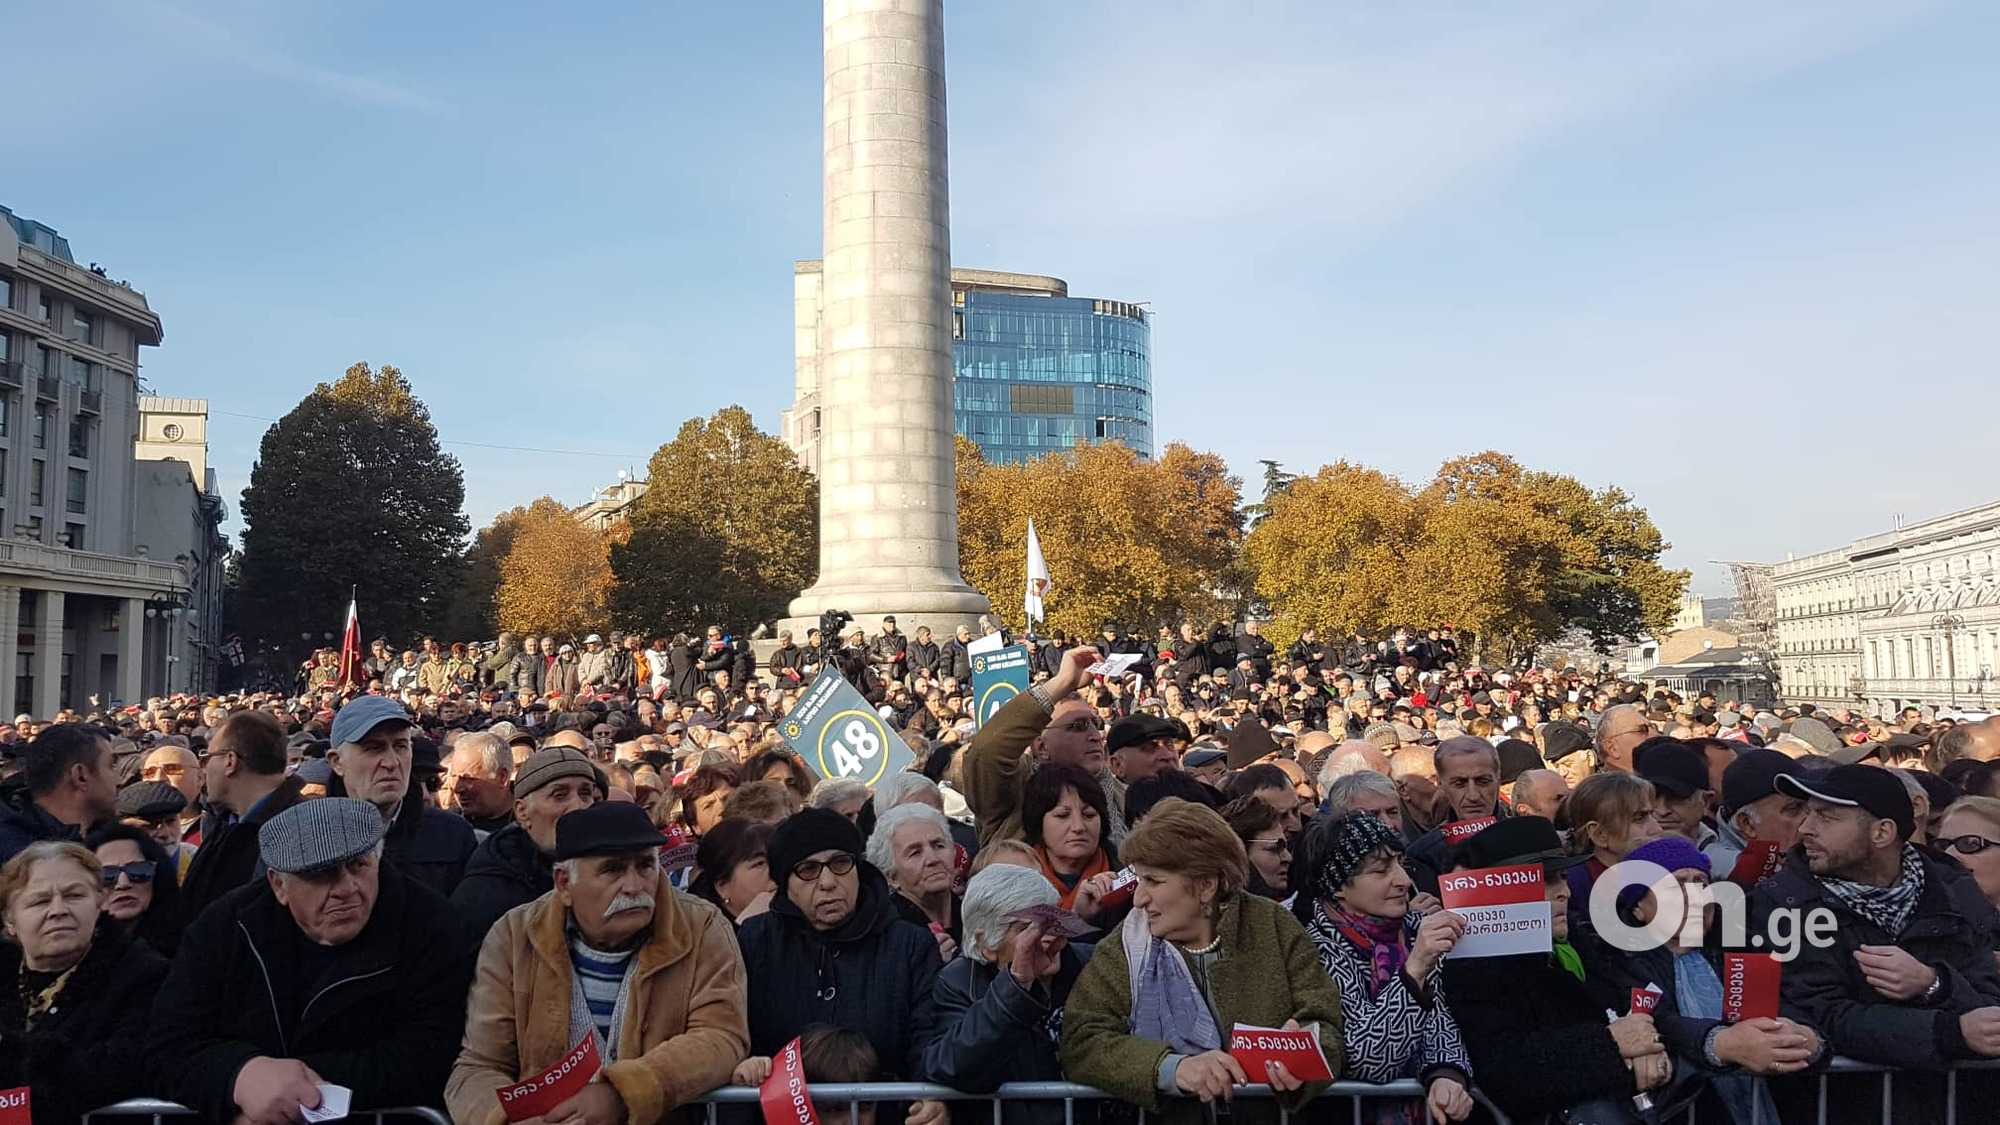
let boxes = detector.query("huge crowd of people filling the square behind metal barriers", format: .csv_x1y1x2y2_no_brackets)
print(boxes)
0,619,2000,1125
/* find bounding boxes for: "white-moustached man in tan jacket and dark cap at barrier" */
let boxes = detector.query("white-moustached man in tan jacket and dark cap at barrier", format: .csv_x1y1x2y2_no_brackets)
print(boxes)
446,803,750,1125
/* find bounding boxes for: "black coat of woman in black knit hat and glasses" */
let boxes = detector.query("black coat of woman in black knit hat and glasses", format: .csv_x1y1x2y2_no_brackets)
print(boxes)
738,863,940,1081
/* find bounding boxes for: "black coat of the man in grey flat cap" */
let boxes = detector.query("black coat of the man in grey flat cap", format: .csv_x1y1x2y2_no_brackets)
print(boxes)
148,863,472,1121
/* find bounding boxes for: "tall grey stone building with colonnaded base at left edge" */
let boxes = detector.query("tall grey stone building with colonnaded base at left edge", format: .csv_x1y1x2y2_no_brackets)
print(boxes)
0,206,188,719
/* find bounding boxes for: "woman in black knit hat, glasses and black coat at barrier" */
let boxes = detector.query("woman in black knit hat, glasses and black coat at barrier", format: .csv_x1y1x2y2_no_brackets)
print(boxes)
736,809,944,1125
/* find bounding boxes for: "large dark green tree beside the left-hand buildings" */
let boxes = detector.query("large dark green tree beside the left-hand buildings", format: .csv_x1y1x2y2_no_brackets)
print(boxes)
240,362,468,649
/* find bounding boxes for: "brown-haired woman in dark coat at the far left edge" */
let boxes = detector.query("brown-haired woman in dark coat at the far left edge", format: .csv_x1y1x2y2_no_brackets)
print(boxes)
0,841,166,1125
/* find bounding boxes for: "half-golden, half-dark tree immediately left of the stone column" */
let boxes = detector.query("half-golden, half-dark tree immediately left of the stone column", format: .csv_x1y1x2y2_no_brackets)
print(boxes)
610,406,820,633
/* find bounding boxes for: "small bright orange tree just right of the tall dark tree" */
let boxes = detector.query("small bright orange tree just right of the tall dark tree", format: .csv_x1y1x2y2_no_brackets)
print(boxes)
494,496,612,637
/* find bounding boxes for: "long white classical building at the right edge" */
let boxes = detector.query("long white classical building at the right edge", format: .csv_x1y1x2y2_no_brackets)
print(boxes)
1772,502,2000,715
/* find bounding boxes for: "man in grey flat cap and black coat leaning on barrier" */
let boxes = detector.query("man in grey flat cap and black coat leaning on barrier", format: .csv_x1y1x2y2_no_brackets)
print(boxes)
148,797,470,1125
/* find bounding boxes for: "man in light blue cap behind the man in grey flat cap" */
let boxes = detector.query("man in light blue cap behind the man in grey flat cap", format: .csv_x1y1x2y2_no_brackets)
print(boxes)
326,695,480,897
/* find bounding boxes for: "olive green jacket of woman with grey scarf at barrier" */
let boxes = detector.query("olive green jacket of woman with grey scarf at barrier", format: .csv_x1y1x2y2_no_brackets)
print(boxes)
1062,891,1342,1125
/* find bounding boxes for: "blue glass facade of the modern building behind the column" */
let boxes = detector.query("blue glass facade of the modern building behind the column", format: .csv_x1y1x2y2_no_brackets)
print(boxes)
952,286,1152,464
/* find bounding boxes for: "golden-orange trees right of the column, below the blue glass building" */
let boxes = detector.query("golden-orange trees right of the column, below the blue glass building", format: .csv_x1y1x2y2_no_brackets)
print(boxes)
958,438,1242,635
